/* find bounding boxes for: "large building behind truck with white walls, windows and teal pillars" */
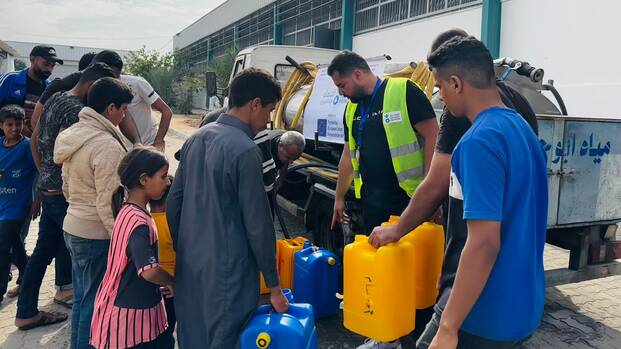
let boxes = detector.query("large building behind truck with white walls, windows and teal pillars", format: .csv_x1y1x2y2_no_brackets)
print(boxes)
173,0,621,117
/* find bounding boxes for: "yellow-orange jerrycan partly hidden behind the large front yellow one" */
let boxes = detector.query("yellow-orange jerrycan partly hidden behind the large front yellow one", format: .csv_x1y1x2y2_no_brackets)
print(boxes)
382,216,444,309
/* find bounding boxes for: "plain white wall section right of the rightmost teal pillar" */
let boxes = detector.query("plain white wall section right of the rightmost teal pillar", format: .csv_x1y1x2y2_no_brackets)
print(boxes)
500,0,621,118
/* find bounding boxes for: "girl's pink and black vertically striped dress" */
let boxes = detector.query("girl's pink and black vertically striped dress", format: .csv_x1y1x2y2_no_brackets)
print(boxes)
90,204,168,349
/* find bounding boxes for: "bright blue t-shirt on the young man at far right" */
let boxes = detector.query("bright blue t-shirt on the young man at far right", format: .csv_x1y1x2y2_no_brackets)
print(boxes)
449,107,548,341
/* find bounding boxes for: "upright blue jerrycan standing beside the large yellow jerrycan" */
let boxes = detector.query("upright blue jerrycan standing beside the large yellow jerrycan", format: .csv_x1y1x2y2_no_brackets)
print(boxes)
293,241,339,319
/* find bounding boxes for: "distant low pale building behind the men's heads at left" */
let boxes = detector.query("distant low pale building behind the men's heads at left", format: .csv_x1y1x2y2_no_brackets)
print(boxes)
7,41,128,79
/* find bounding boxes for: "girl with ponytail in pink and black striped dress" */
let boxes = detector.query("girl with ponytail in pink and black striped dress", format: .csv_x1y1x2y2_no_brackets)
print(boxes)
90,147,172,349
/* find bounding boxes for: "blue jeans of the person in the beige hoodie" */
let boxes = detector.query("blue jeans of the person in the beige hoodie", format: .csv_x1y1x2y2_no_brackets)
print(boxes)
65,232,110,349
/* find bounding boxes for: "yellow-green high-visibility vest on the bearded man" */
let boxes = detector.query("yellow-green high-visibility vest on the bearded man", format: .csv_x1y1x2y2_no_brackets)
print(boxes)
345,78,425,199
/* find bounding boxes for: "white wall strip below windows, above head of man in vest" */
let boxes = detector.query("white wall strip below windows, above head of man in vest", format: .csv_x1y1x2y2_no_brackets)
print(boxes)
353,6,481,62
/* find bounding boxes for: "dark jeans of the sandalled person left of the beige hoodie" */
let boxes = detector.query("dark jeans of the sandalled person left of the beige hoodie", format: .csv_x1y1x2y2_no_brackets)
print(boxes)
17,195,71,319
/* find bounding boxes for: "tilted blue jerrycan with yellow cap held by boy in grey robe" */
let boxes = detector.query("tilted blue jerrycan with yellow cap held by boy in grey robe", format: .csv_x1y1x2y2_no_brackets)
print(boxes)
240,290,319,349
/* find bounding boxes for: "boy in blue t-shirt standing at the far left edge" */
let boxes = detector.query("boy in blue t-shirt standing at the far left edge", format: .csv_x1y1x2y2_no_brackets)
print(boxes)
0,105,37,301
